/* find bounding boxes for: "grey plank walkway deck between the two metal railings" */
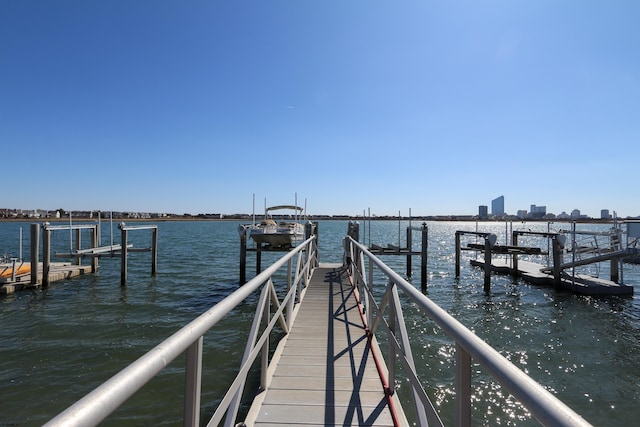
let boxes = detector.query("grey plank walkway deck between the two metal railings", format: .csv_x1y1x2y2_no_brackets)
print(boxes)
246,264,407,427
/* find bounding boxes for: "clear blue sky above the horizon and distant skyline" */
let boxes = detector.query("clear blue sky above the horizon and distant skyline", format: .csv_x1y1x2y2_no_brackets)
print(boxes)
0,0,640,217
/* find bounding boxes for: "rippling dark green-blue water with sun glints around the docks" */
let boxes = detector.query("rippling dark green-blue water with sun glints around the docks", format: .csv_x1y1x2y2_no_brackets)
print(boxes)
0,221,640,426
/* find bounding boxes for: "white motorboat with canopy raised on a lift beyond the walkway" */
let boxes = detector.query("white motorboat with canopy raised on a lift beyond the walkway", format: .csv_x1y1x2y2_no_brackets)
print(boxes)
249,205,304,249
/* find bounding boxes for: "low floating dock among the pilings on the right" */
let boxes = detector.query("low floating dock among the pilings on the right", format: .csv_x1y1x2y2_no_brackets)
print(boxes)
470,258,633,296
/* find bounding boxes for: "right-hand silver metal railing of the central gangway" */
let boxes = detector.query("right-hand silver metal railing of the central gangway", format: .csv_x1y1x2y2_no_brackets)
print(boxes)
344,236,590,426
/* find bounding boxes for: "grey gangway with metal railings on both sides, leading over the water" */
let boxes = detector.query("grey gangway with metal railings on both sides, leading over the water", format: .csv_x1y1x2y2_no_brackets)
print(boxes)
46,229,589,427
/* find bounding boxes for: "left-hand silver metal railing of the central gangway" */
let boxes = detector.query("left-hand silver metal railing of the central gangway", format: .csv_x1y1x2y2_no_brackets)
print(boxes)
45,236,318,427
